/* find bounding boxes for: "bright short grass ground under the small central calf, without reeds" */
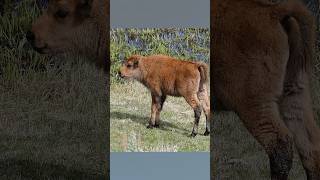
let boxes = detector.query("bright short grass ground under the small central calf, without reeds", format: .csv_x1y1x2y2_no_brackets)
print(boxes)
110,82,210,152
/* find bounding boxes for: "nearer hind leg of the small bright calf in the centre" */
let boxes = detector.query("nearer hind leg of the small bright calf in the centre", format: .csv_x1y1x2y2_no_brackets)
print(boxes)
184,94,202,137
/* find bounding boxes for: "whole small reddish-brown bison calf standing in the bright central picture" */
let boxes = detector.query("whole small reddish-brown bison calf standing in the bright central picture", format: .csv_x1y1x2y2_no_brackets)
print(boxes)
119,55,210,136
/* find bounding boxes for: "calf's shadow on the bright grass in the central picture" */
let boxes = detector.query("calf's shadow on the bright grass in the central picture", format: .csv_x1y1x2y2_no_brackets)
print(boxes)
110,112,191,135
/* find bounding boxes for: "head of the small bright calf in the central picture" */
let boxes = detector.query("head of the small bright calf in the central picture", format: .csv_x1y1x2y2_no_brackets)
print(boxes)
119,55,142,80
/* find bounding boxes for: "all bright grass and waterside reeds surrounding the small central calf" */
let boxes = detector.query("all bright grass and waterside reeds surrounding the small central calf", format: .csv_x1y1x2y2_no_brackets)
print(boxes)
110,28,210,152
